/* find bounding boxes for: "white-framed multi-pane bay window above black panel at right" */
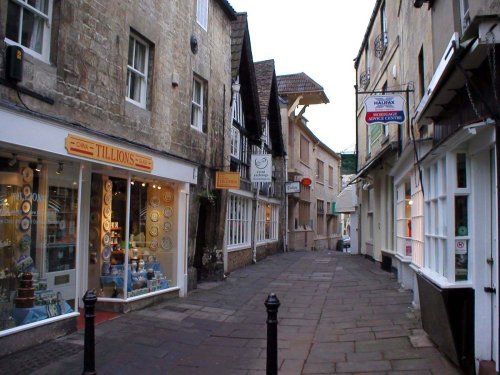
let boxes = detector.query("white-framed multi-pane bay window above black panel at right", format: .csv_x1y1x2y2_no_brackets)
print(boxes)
424,152,472,284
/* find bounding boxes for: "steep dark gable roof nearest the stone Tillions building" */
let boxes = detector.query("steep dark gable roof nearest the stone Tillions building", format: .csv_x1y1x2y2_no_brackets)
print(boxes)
231,13,262,141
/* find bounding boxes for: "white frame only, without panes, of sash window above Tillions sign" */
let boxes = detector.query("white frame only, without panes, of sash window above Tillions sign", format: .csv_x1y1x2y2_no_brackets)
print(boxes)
126,32,149,108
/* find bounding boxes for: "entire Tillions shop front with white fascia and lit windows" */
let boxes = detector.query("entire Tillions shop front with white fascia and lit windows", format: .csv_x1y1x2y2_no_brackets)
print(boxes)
0,108,197,355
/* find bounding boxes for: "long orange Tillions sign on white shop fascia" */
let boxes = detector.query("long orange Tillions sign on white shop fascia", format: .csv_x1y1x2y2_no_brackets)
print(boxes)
65,134,153,172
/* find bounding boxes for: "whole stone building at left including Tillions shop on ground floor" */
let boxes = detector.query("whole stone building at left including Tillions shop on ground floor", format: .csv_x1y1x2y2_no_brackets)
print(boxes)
0,0,235,354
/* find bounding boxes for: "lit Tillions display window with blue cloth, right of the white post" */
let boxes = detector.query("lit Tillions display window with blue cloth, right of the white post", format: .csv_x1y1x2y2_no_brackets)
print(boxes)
89,174,177,298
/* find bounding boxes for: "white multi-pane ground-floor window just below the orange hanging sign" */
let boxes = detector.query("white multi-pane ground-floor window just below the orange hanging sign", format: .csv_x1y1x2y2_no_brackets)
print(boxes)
226,194,252,250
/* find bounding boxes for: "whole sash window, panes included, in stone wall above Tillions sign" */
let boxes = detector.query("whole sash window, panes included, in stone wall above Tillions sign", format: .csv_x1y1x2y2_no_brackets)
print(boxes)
127,33,149,108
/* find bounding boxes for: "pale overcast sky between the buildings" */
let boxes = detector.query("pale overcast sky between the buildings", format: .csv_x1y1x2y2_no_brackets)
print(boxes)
229,0,375,153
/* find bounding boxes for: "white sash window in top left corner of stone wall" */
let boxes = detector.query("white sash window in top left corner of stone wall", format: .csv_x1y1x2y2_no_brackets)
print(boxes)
5,0,53,61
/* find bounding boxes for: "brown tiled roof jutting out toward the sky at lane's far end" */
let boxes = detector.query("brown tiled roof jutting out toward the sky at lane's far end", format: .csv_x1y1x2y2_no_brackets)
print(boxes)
277,73,330,105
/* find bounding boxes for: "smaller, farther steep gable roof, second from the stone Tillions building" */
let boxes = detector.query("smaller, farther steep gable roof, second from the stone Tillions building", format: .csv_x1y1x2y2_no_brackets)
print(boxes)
254,60,285,156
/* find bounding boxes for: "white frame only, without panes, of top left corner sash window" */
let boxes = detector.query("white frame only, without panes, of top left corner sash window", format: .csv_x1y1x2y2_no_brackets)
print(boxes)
5,0,53,63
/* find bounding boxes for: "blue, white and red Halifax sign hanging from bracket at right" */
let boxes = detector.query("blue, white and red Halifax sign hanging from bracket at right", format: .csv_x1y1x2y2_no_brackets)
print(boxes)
365,95,406,125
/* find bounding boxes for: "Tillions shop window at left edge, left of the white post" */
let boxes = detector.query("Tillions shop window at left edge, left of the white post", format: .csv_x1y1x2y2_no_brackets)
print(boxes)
0,155,79,330
